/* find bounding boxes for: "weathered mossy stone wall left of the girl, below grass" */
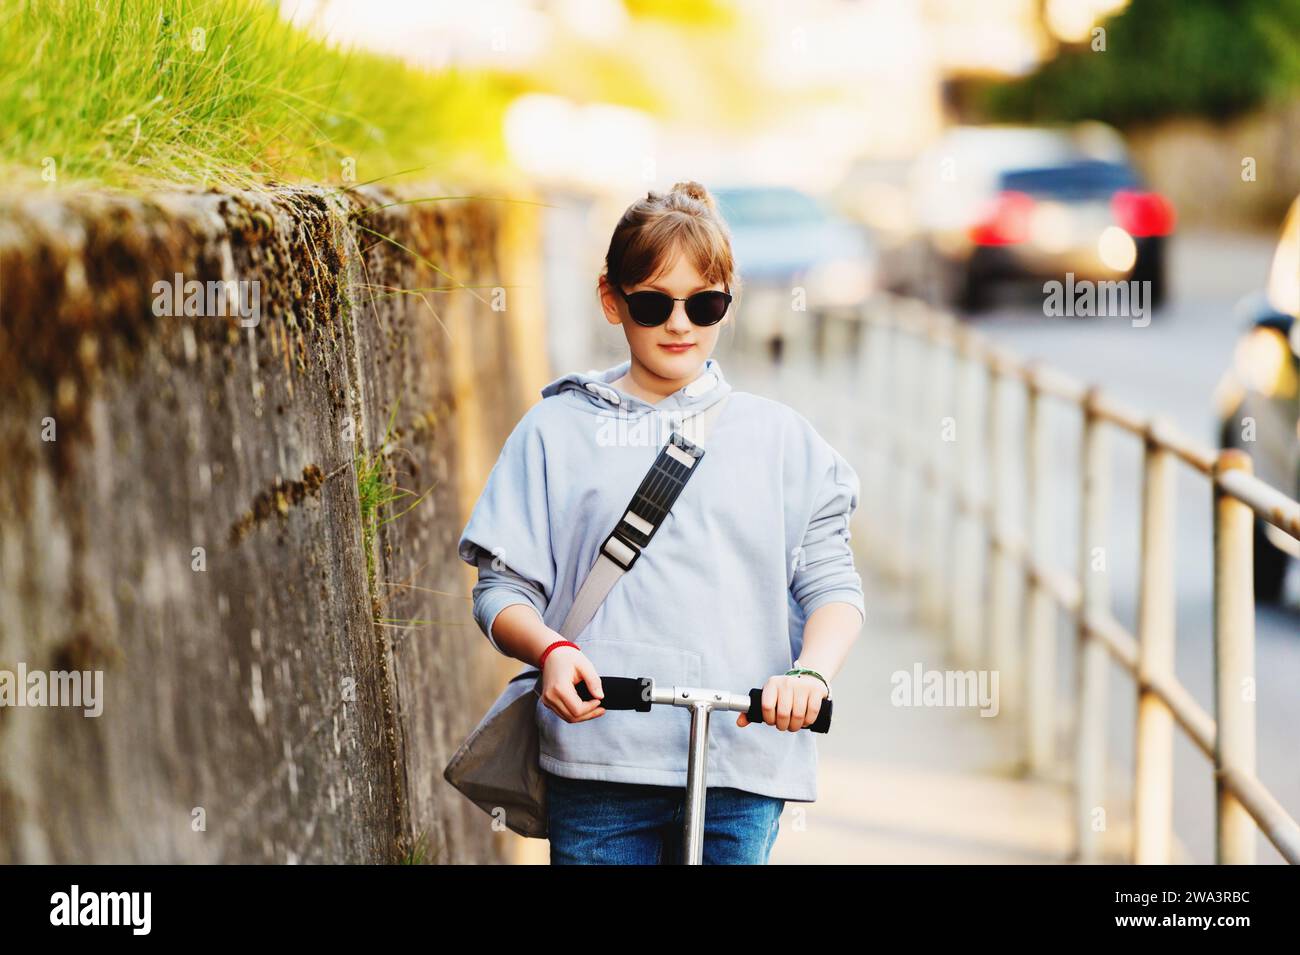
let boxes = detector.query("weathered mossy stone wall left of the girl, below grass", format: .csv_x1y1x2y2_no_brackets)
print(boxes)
0,188,546,863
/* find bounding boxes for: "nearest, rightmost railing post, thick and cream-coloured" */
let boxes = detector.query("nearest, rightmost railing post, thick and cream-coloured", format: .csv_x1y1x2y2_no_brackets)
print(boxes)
1214,450,1256,865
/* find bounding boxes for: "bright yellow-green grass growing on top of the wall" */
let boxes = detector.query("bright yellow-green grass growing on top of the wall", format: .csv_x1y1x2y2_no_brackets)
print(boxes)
0,0,515,187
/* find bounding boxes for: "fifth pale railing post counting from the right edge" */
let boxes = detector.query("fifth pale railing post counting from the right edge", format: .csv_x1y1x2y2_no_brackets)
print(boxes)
985,356,1024,715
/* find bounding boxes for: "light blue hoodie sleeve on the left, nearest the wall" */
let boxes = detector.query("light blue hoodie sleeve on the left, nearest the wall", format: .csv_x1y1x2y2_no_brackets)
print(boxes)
458,405,555,654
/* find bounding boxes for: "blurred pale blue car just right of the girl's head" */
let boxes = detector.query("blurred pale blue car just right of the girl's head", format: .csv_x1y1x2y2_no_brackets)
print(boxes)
714,186,875,359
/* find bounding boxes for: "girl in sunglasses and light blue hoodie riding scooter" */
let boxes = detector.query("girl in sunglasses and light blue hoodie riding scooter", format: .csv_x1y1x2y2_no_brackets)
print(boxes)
459,182,865,864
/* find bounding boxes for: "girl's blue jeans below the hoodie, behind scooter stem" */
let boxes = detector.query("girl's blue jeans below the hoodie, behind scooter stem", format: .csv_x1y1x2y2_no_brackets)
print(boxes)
546,773,785,865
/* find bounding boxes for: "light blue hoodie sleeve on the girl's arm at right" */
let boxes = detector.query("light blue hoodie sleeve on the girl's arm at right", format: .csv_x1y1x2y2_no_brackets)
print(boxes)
790,442,867,631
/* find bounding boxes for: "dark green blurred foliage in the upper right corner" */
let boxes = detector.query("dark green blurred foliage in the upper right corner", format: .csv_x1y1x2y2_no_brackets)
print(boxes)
983,0,1300,126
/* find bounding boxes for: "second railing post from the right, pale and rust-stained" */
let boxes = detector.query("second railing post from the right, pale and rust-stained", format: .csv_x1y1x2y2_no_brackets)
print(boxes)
1132,422,1175,865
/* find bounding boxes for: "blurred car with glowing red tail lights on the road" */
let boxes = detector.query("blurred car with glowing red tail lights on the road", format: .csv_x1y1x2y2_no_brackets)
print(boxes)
914,123,1175,312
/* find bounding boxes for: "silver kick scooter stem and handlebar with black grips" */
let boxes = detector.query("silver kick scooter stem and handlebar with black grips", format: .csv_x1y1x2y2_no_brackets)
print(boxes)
577,677,831,865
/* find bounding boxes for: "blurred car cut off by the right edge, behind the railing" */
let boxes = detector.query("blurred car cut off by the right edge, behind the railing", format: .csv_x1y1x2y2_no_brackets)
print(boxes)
1216,196,1300,603
